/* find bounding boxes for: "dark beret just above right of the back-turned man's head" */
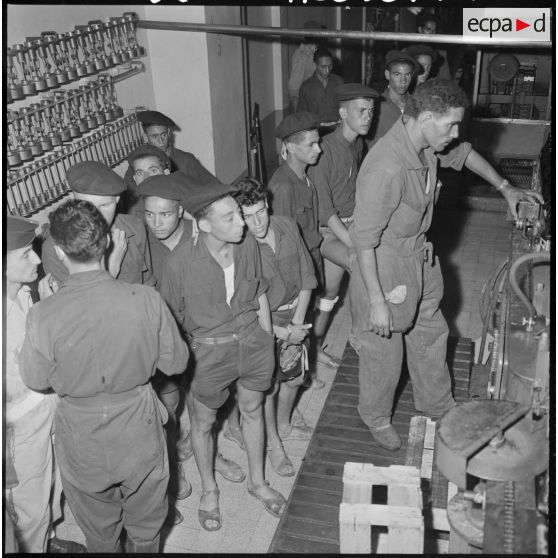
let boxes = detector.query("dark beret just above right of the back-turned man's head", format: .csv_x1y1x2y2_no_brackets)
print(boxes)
66,161,126,196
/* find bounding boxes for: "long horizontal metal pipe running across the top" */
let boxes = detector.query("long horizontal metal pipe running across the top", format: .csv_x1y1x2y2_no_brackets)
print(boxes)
137,20,552,49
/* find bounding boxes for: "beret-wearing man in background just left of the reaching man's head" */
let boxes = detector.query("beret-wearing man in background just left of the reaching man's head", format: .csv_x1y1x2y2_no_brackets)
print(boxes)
368,50,419,149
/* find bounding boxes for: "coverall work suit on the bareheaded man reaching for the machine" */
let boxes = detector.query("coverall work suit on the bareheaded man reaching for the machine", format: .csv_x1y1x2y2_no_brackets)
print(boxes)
350,119,471,428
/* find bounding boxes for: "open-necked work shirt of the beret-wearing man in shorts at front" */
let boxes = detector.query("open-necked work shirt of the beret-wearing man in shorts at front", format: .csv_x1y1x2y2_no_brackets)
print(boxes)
160,231,268,337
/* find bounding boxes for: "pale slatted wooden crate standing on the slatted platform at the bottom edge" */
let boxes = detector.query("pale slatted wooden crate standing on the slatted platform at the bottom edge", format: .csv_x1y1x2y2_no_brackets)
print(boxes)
339,463,424,554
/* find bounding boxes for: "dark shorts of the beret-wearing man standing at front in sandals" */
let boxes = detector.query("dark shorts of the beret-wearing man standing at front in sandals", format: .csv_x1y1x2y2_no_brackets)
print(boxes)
190,323,275,409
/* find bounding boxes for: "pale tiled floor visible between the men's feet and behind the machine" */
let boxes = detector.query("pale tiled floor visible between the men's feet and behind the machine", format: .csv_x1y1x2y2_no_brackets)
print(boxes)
57,208,511,554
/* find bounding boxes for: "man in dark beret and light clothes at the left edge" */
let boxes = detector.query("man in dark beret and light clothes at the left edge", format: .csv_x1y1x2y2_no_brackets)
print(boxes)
4,216,85,553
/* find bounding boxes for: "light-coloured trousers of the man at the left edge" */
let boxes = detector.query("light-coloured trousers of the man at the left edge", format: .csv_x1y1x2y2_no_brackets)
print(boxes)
7,394,62,553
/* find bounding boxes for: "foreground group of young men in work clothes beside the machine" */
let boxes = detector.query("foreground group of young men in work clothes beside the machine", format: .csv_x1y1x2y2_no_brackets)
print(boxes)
6,46,536,552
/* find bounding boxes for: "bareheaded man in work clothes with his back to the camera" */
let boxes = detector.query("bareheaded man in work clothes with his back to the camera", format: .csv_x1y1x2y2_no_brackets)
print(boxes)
20,200,188,553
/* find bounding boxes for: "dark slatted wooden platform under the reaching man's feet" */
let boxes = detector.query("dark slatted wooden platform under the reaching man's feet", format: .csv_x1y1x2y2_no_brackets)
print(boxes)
269,337,472,554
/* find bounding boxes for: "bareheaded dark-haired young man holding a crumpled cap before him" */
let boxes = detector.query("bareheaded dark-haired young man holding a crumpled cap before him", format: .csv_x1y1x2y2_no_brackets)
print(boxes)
229,178,317,477
